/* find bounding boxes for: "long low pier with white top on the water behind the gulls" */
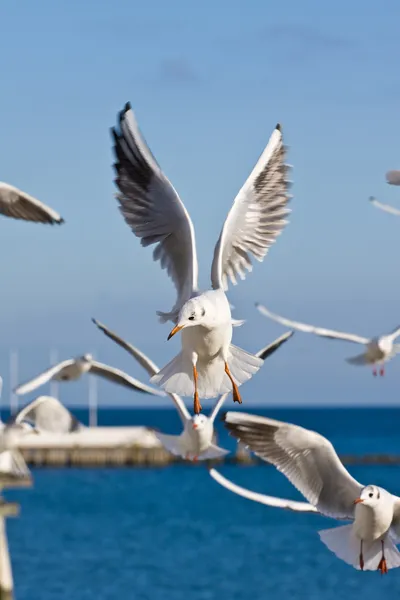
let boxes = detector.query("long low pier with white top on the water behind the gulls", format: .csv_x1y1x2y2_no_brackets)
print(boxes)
10,427,400,468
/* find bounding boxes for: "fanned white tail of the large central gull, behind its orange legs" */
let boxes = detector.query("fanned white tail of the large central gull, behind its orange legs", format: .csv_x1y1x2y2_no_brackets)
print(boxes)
150,344,263,398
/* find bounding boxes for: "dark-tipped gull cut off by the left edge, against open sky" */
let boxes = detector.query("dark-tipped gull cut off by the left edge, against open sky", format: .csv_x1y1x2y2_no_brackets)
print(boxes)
0,181,64,225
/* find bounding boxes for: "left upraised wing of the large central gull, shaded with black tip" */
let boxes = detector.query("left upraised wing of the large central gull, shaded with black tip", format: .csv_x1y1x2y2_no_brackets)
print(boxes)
112,103,198,321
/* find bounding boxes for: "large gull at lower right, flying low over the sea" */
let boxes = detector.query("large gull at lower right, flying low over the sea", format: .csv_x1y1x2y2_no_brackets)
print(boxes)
224,412,400,574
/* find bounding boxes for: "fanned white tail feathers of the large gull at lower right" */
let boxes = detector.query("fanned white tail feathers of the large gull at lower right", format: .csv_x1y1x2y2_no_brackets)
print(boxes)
318,525,400,571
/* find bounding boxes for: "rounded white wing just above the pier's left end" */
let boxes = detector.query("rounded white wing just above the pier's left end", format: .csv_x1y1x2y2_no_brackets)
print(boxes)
7,396,84,433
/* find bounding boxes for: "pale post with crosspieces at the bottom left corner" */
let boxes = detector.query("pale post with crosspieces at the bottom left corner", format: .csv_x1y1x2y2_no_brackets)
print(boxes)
0,476,32,600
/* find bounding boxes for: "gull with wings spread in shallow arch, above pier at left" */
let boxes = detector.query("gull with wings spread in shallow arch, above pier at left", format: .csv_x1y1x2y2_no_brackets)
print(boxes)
14,354,165,396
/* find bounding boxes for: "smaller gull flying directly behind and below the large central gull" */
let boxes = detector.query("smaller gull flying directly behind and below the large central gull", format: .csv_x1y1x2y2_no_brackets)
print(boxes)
92,319,294,462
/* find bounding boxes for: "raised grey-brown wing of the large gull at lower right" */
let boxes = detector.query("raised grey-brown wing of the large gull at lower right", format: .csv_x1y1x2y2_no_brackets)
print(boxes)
224,412,363,519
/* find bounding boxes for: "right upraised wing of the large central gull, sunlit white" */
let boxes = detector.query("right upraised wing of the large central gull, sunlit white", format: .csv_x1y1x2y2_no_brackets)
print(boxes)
211,124,290,290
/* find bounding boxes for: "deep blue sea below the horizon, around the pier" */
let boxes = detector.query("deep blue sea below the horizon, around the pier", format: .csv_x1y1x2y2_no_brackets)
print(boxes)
5,405,400,600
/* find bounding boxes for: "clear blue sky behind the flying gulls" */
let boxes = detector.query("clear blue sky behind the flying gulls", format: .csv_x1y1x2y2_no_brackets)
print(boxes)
0,0,400,404
